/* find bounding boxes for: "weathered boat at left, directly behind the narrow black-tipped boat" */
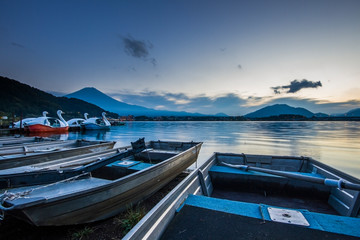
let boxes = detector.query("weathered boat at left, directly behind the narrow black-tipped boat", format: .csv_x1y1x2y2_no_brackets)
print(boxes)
0,140,115,170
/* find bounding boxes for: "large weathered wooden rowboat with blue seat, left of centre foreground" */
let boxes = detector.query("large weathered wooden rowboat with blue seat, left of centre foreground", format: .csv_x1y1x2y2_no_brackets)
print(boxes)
0,141,202,226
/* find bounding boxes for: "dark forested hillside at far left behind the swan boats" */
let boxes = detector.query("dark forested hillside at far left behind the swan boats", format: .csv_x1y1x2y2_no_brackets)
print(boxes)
0,76,116,119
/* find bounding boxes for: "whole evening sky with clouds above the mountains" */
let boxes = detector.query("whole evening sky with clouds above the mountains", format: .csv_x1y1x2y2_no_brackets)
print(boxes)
0,0,360,115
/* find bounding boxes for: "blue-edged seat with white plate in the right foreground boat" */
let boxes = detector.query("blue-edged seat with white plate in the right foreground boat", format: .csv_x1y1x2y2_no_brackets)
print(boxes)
167,195,360,239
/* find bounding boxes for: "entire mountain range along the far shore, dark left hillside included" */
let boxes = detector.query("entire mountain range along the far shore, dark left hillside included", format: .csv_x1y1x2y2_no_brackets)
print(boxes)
0,76,360,119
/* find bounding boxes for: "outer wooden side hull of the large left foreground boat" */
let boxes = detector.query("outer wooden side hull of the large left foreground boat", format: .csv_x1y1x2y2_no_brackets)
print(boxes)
2,143,201,226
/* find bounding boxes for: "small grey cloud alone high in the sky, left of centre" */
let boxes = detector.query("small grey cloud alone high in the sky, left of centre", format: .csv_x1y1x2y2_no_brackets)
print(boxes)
121,35,157,66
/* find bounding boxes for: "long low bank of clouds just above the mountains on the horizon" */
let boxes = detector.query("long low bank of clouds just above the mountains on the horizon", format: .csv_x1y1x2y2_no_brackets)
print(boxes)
109,91,360,116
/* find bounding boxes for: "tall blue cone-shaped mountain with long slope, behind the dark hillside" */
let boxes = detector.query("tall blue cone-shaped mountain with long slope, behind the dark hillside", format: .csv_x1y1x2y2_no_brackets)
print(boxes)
65,87,202,116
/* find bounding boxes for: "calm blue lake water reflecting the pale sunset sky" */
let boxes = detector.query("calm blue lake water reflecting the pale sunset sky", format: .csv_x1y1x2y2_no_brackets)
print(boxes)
55,122,360,178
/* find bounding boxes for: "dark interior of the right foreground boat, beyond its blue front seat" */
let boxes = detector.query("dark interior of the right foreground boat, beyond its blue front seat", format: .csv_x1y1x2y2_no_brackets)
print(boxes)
208,154,360,216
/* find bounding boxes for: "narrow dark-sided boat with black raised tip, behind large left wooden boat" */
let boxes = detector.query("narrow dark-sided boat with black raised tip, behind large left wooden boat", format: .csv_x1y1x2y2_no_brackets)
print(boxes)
0,139,145,189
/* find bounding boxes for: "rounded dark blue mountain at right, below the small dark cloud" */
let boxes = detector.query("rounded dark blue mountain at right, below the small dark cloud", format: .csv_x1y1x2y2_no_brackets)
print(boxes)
244,104,314,118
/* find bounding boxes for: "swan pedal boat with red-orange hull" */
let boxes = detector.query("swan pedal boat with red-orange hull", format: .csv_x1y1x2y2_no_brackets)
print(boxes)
24,110,69,133
